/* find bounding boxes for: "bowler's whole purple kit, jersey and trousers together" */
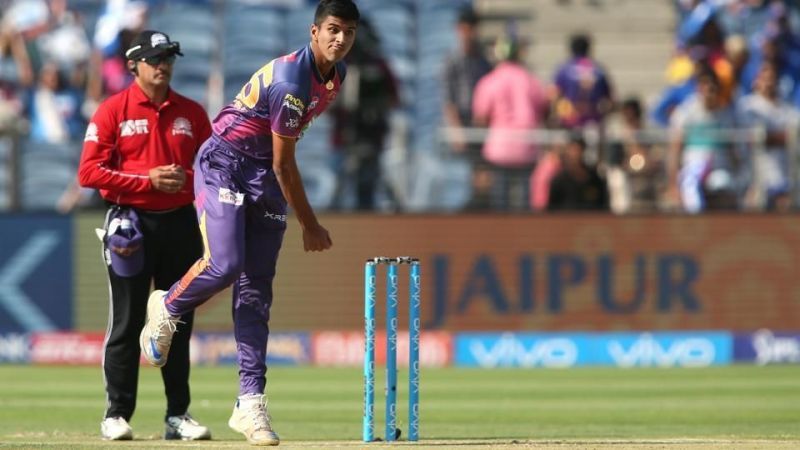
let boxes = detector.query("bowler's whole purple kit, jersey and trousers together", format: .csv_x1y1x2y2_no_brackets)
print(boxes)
165,46,345,395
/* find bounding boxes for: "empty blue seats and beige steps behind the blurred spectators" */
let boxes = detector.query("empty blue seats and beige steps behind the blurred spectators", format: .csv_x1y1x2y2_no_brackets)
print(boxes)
0,0,673,210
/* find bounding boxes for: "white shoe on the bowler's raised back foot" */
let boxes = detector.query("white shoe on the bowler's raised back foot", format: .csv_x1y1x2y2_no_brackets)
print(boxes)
139,290,181,367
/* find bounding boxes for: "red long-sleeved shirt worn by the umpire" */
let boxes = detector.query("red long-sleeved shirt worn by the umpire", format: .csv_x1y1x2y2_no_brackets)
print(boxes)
78,83,211,211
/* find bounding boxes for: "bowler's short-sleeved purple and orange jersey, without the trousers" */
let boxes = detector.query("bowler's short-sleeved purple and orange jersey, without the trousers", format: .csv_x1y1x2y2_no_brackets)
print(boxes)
212,45,345,159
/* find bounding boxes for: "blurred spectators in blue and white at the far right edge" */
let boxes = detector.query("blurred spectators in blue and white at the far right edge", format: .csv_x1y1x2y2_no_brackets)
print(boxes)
652,0,800,212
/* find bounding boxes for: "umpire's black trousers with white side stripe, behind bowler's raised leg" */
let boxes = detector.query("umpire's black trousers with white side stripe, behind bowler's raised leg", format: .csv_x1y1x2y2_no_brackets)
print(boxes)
103,205,203,421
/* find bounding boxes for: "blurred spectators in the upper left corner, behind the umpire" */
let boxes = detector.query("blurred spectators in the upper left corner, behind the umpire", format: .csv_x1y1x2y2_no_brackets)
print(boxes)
0,0,154,144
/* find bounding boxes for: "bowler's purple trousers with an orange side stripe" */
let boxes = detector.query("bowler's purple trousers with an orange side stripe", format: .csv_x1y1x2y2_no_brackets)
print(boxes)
166,137,286,395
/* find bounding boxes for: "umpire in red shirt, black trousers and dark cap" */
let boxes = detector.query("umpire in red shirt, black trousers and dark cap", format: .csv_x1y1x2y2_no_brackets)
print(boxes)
78,31,211,440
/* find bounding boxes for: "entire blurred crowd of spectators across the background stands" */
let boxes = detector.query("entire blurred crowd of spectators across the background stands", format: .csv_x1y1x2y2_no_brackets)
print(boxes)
0,0,800,213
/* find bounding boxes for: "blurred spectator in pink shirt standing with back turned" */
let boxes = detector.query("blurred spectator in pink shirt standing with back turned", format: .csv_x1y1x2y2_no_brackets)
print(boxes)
472,32,549,209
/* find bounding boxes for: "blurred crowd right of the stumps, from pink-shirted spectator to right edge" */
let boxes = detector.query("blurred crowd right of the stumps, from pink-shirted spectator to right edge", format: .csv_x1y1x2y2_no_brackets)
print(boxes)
443,0,800,213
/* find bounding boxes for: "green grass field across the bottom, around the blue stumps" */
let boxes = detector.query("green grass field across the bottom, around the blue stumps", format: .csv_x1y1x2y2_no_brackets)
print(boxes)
0,365,800,448
